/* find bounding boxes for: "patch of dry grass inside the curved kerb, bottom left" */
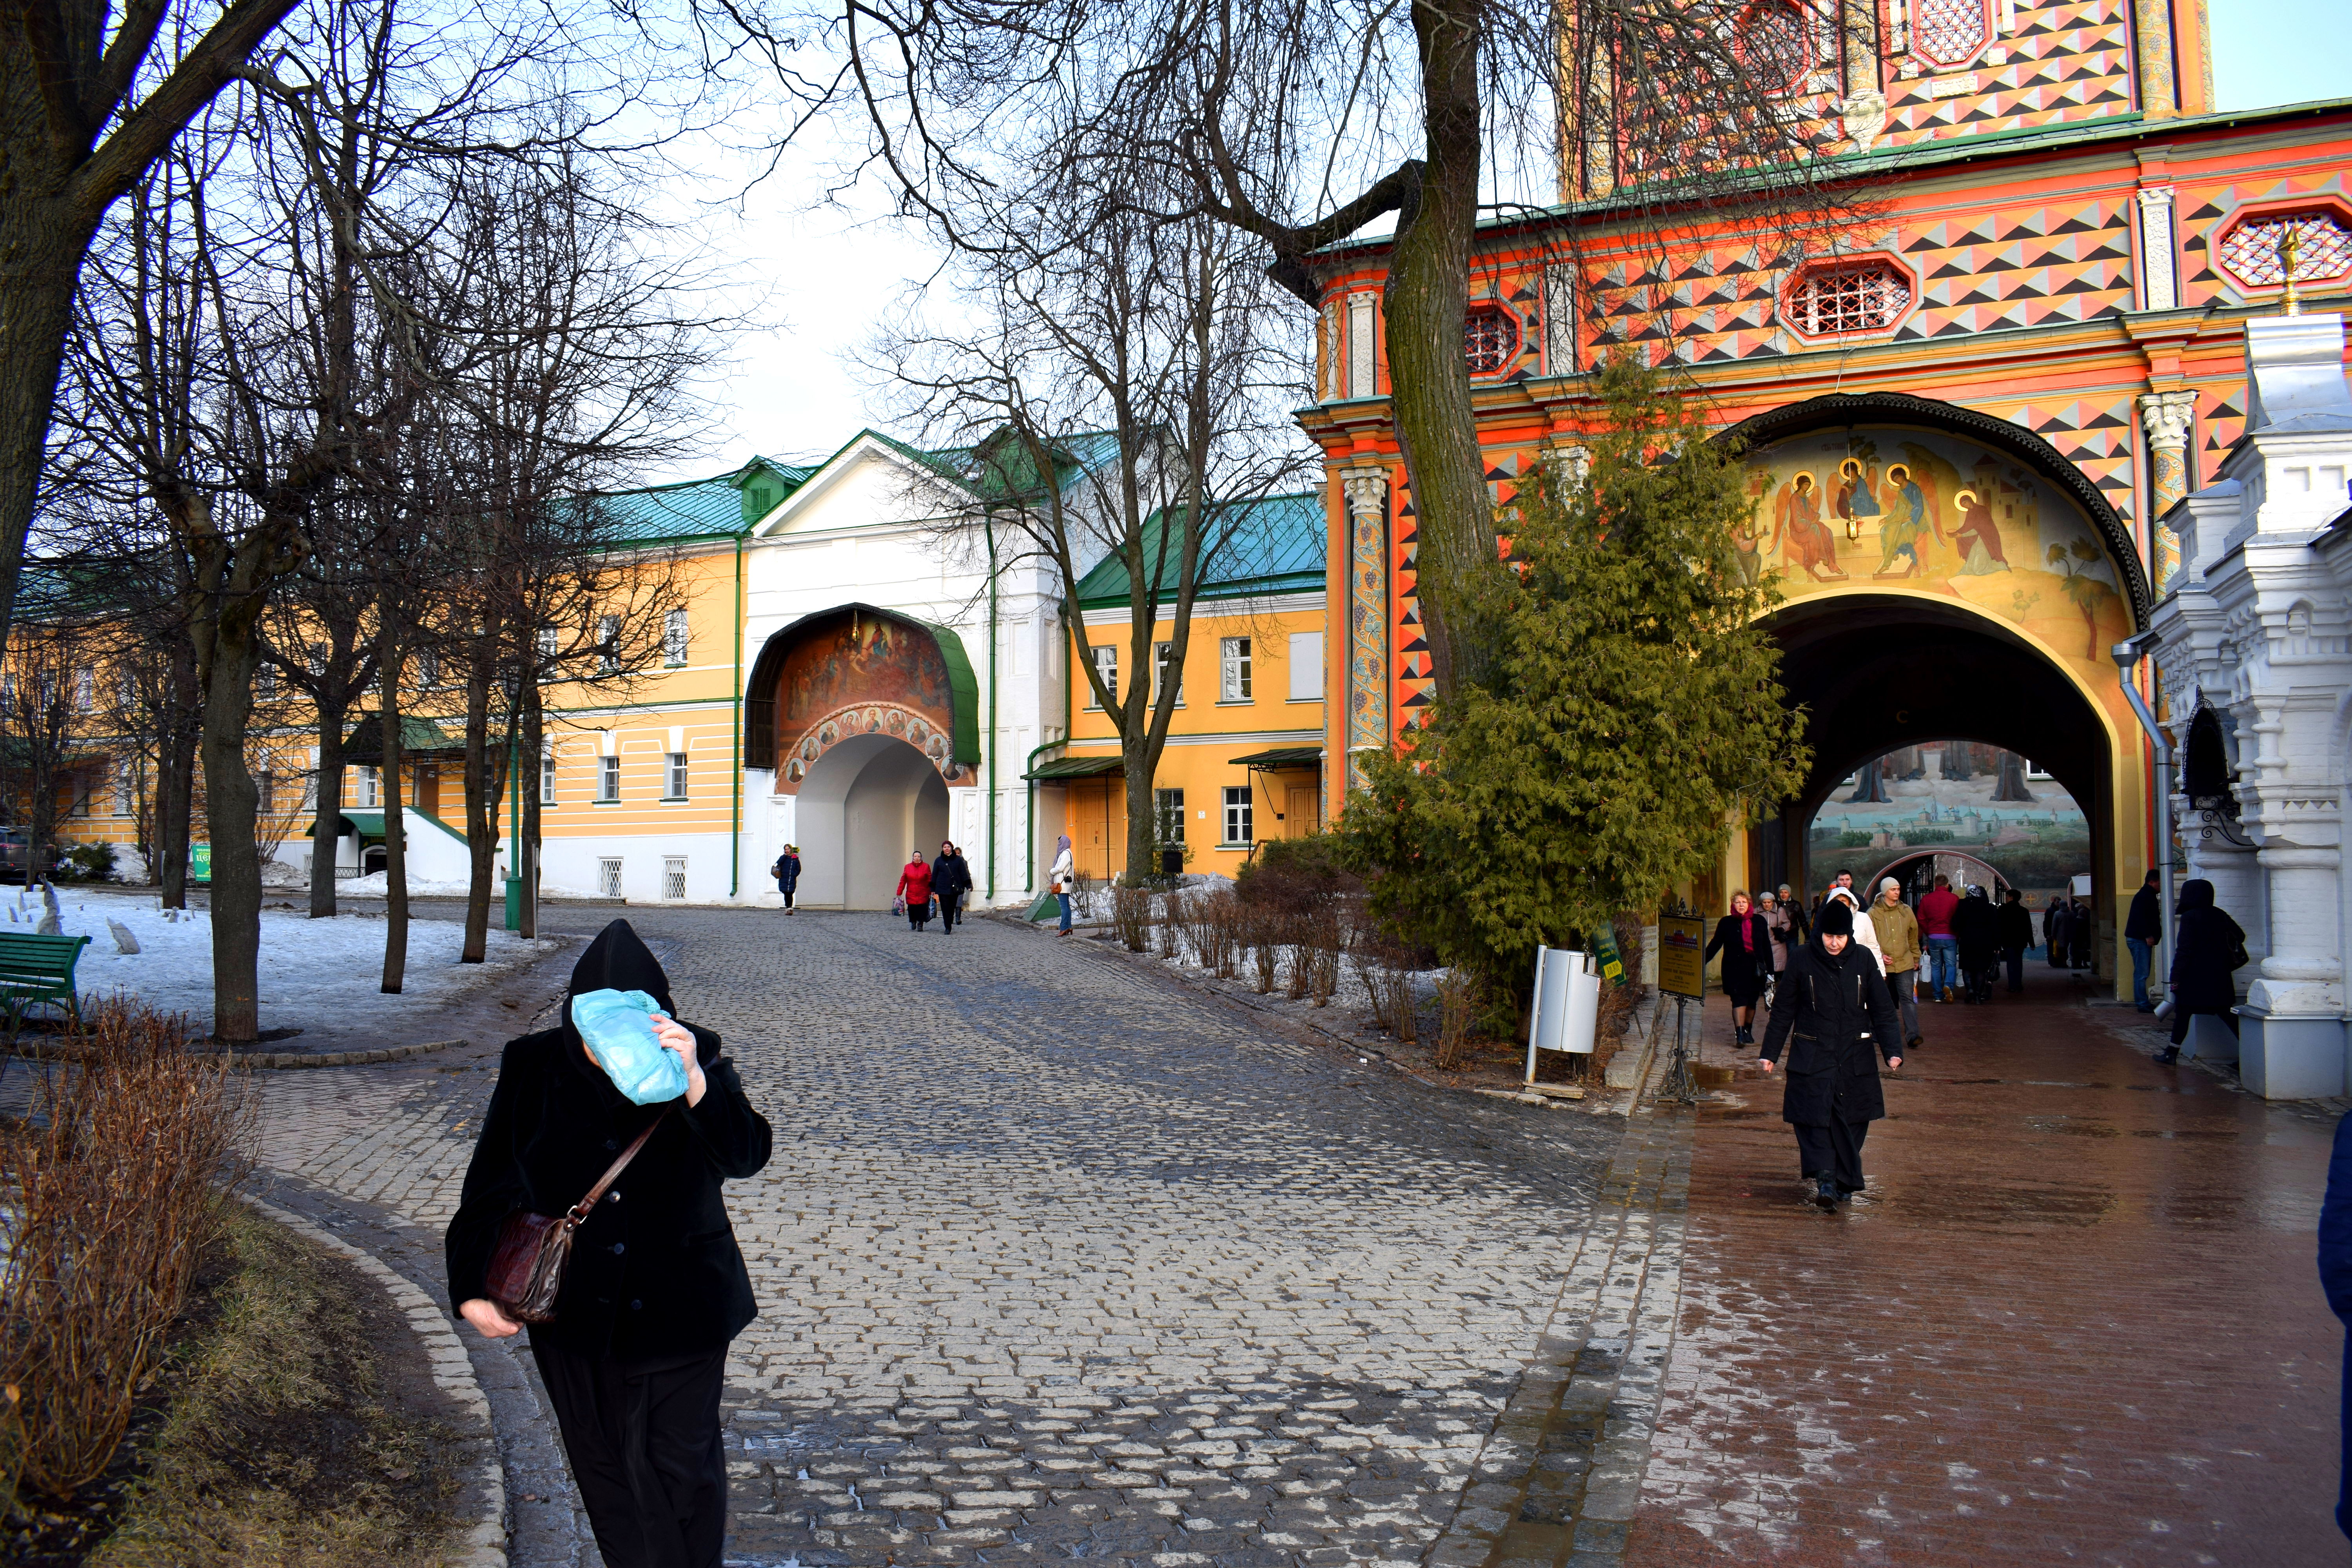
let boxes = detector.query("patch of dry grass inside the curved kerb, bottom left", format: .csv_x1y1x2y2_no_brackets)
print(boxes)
87,1208,459,1568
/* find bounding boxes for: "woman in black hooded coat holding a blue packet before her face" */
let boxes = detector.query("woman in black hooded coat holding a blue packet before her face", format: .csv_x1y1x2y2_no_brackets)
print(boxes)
447,919,769,1568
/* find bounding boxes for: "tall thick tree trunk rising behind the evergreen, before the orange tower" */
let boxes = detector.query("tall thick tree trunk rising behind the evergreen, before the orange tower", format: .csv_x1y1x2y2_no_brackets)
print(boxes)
1381,0,1498,696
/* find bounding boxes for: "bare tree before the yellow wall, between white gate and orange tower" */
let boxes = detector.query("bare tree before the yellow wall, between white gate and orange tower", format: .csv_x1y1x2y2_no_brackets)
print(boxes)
887,138,1308,875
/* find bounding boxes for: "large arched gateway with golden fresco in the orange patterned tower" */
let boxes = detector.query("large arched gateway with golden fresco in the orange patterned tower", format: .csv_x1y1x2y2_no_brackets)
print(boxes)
1719,395,2150,976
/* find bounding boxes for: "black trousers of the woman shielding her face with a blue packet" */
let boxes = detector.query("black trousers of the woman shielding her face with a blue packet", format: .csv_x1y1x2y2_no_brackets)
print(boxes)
532,1338,727,1568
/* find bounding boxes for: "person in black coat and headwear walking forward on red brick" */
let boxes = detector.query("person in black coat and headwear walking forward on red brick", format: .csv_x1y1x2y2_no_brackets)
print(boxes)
1762,900,1903,1208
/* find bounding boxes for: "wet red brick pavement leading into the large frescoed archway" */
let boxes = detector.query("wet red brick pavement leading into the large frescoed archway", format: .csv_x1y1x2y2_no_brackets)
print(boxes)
1625,966,2347,1568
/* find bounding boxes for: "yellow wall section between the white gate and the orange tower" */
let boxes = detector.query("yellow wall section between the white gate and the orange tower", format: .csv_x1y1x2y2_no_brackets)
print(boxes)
1061,599,1329,879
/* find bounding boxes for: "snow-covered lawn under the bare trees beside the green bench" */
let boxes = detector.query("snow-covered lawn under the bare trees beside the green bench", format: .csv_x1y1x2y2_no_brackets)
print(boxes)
22,886,562,1051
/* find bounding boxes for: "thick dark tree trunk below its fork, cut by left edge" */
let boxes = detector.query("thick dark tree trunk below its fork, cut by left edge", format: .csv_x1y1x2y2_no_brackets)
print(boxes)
0,222,96,663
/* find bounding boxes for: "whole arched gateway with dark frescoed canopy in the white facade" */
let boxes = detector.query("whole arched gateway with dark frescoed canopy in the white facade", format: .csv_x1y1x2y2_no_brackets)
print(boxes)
743,604,981,910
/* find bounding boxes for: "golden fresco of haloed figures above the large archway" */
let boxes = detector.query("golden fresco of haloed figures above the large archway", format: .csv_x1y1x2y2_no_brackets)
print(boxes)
1733,428,2131,665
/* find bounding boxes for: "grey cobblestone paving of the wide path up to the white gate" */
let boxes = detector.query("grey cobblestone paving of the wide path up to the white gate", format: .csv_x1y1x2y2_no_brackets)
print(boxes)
248,910,1625,1566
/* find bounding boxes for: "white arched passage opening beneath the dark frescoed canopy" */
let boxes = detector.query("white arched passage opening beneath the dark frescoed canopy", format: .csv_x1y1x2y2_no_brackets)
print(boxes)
793,736,948,910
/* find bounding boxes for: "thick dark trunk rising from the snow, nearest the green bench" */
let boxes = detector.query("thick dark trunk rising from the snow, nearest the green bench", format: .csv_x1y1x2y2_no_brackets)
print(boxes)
202,616,261,1046
